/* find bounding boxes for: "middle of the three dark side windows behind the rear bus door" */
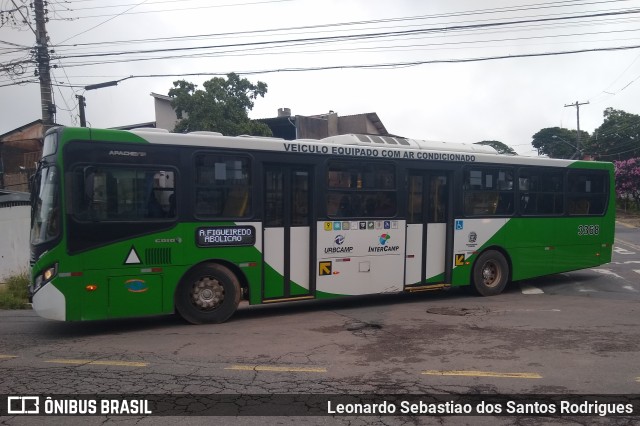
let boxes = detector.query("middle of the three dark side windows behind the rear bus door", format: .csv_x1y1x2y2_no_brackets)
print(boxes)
518,168,564,216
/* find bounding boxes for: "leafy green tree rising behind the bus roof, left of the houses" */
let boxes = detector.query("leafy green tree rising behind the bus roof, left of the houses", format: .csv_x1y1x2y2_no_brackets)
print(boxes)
169,73,272,136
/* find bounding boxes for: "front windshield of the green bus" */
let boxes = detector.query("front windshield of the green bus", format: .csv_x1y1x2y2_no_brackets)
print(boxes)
31,166,60,244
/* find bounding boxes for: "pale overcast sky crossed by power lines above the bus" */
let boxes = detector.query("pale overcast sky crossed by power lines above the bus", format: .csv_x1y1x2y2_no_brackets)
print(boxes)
0,0,640,154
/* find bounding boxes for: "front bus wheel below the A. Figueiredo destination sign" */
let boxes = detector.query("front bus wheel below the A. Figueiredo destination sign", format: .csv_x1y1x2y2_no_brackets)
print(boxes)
175,263,241,324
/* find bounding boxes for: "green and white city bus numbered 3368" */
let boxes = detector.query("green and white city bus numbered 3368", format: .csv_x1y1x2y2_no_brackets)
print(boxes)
30,127,615,323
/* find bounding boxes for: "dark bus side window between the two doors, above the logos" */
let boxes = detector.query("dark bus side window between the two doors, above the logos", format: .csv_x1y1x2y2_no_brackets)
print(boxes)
326,161,397,218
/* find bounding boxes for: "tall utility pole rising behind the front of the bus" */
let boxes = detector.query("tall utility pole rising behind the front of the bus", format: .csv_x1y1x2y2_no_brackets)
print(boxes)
33,0,56,131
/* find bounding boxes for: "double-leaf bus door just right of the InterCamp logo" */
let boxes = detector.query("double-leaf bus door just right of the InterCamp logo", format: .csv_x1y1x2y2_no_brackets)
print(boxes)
405,171,453,286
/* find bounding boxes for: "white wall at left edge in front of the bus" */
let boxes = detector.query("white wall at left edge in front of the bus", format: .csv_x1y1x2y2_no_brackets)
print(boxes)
0,206,30,282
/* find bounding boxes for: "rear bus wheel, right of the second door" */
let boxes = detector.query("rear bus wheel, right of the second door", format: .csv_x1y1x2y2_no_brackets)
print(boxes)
473,250,509,296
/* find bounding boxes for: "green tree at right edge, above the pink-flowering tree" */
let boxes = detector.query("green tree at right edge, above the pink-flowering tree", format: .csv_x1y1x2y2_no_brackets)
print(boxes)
586,108,640,161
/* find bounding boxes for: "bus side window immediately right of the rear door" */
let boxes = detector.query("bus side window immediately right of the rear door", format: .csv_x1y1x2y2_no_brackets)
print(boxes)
463,167,514,216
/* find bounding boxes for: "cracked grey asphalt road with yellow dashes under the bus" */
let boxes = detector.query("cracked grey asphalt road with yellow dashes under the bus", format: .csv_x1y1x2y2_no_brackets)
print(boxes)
0,221,640,425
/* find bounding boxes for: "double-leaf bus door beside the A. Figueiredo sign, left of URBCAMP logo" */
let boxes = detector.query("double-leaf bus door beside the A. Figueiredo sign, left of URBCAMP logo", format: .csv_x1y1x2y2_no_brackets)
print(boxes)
262,164,315,302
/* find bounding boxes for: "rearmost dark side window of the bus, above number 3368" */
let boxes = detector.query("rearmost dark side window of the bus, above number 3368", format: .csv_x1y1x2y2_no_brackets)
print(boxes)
567,170,609,215
